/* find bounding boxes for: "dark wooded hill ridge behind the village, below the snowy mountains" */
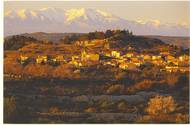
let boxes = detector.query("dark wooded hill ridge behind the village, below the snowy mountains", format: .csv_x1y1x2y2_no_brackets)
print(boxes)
5,30,167,50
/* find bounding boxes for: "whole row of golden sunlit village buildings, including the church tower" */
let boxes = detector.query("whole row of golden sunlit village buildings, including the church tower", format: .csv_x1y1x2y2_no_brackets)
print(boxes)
19,49,190,72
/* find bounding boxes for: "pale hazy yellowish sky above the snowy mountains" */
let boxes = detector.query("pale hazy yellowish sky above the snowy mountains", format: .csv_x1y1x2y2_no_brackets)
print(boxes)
4,1,190,25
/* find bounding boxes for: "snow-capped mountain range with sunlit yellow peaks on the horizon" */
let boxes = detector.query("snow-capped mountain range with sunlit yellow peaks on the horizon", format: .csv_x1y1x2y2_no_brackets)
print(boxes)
4,8,190,36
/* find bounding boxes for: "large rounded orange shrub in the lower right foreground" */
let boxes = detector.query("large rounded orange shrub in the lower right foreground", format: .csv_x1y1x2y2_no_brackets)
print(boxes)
146,96,177,115
